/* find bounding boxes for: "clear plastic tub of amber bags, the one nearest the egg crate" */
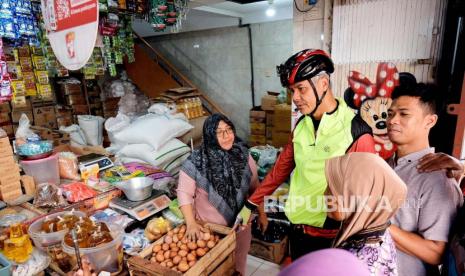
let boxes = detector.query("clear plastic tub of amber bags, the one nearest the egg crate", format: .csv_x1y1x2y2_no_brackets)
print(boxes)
62,222,123,274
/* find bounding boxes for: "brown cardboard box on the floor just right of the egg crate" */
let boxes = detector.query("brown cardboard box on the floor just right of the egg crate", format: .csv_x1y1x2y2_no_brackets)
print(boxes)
249,237,288,264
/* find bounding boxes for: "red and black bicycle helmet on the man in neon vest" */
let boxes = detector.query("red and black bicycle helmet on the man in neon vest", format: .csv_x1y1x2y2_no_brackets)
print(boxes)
277,49,334,87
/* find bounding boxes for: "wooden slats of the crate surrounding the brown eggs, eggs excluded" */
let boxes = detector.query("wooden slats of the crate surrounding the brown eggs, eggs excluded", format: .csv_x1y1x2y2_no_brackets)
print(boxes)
128,223,236,276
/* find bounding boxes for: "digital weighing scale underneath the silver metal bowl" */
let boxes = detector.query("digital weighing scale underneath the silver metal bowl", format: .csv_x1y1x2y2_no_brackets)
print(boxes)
110,190,171,221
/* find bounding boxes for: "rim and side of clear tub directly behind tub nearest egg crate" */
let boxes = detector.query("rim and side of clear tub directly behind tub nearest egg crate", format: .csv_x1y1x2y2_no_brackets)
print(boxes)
27,211,86,251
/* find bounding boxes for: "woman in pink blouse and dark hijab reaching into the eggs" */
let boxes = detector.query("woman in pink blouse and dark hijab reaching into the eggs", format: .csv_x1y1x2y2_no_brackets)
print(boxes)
177,114,258,275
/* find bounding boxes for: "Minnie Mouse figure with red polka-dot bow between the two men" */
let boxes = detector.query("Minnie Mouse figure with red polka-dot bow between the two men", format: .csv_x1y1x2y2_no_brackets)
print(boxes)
344,62,399,159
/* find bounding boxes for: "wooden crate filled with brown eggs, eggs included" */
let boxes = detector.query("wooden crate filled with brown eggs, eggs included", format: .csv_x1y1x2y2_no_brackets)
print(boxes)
128,223,236,276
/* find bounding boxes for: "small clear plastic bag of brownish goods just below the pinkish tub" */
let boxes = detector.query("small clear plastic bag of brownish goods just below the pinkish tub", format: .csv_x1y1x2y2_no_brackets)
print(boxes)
33,183,67,208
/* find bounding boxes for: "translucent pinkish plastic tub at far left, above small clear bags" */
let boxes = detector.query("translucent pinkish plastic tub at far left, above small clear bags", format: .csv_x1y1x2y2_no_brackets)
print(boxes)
20,154,60,184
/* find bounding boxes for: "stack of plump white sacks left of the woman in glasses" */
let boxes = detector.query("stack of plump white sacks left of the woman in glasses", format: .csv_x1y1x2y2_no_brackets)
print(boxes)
105,104,193,177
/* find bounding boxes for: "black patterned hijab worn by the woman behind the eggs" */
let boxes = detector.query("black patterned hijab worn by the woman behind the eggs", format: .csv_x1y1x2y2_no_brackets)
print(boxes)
182,114,252,225
